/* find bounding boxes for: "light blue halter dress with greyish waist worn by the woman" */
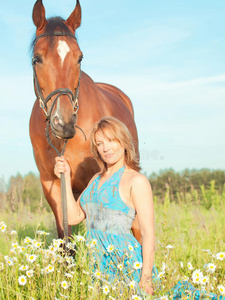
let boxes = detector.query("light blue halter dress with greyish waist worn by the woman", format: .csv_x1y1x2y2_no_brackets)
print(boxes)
80,167,157,284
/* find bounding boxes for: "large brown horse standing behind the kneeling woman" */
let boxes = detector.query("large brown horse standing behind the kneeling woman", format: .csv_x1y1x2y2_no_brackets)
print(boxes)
30,0,141,241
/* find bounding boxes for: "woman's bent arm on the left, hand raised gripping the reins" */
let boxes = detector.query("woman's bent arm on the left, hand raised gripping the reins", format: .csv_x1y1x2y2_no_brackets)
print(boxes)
54,156,86,225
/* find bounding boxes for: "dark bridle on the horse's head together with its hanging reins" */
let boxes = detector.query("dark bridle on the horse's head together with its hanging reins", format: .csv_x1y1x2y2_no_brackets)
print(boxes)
32,32,87,156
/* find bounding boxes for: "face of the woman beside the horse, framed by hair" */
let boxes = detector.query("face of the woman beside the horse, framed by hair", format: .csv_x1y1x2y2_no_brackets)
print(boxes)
95,131,125,166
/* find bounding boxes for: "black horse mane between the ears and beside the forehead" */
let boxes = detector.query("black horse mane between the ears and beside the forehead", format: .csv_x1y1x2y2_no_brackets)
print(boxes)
30,17,76,54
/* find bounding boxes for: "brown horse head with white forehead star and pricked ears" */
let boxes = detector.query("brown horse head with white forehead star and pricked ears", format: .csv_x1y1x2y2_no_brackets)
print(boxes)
32,0,82,139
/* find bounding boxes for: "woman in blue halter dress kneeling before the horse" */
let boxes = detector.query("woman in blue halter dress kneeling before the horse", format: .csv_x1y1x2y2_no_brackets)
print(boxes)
54,117,157,294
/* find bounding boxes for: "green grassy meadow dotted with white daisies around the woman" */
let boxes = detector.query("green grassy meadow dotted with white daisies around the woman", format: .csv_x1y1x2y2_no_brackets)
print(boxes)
0,186,225,300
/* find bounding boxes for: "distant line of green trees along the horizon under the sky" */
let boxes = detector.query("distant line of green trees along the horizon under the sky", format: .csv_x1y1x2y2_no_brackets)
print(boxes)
0,169,225,212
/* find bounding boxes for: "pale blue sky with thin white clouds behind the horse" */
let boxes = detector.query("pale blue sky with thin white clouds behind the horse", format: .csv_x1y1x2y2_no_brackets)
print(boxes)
0,0,225,182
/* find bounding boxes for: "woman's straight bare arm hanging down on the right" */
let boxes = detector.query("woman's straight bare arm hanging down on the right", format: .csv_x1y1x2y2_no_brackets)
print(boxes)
132,173,155,294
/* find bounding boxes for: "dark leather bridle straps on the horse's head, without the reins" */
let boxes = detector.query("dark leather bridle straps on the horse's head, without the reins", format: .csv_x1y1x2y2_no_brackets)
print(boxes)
32,32,81,120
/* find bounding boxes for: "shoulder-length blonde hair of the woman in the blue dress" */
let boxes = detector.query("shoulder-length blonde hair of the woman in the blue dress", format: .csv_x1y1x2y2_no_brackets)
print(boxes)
90,117,141,175
